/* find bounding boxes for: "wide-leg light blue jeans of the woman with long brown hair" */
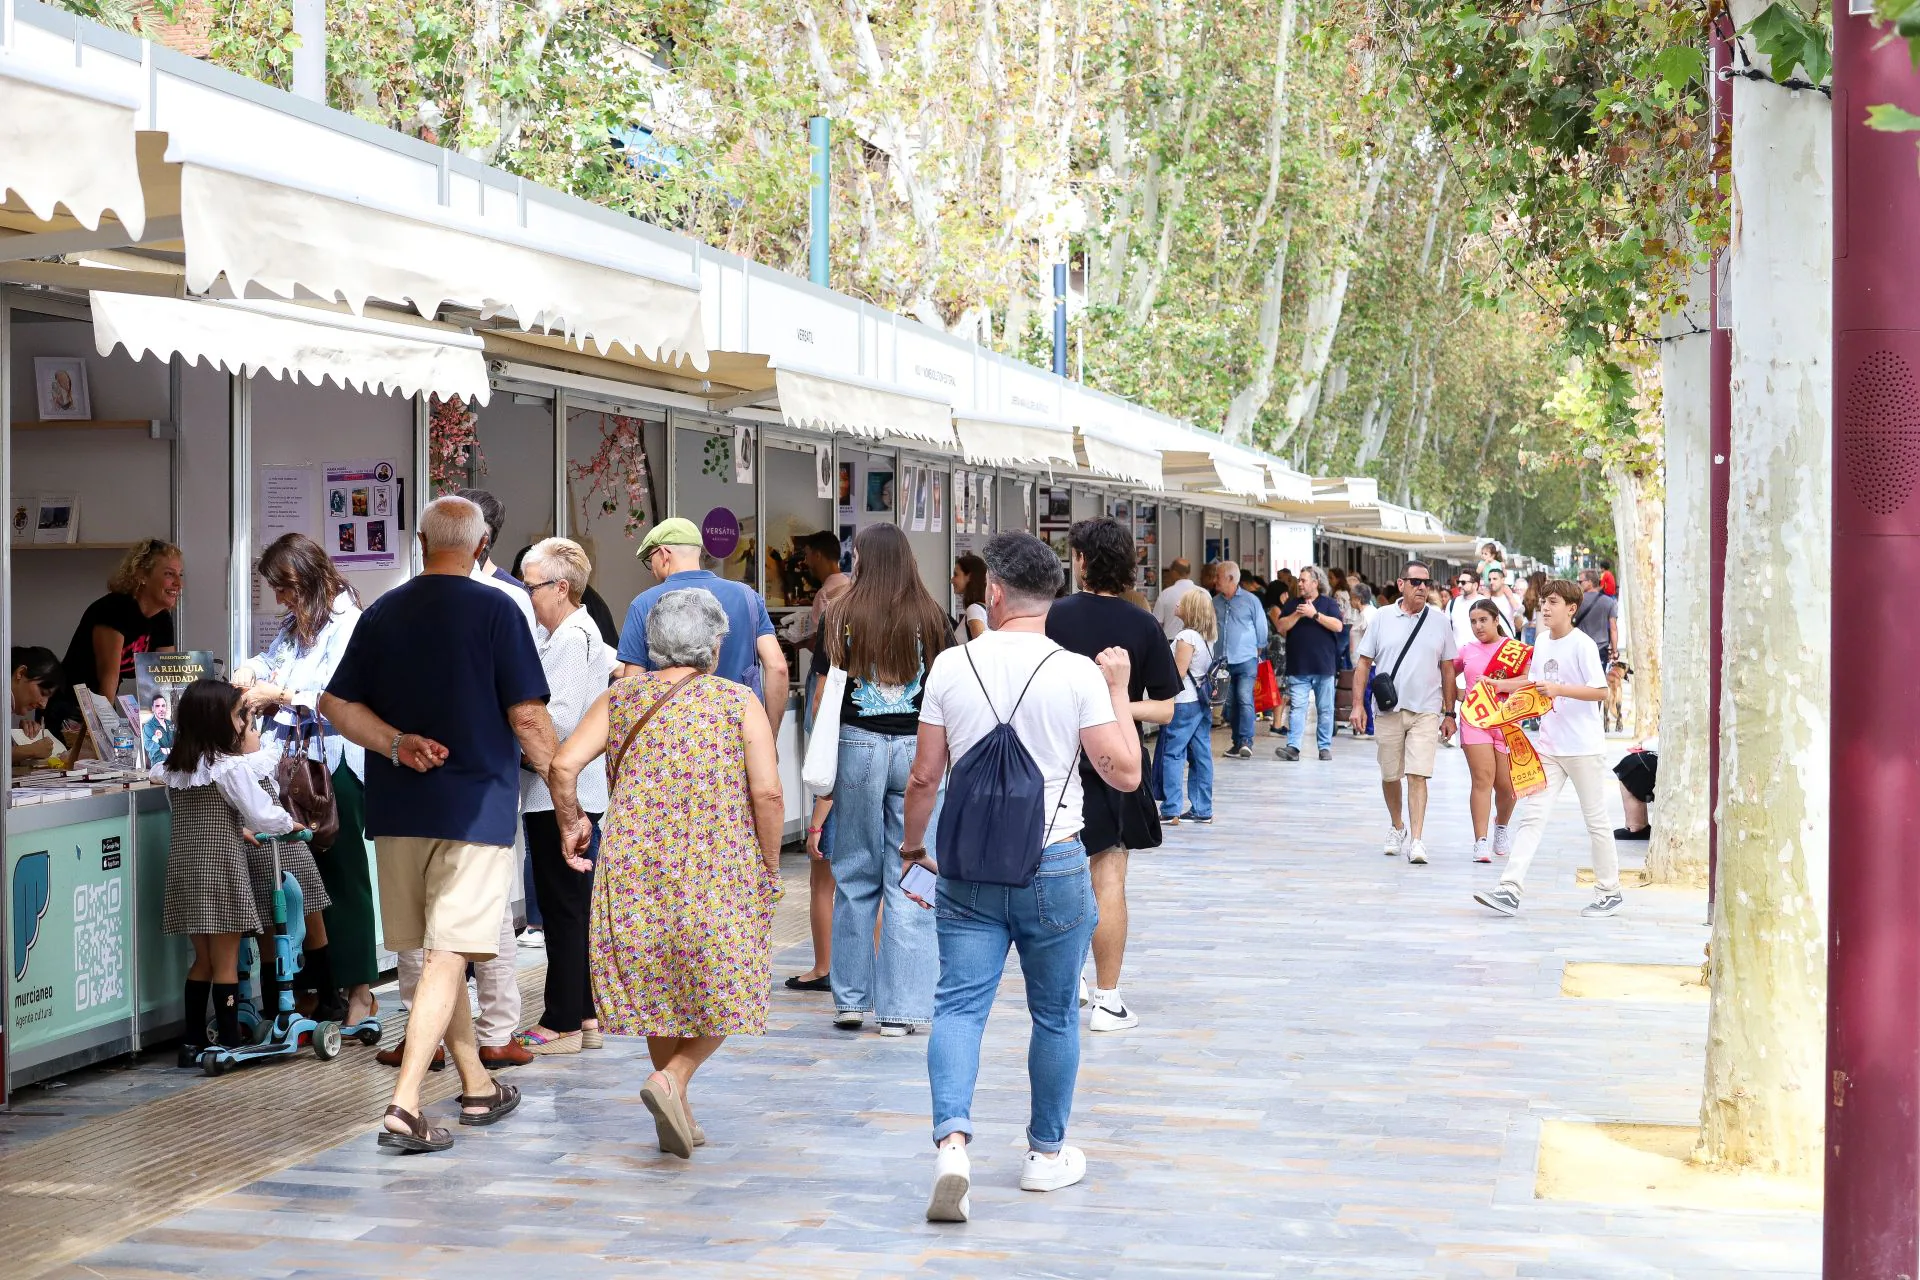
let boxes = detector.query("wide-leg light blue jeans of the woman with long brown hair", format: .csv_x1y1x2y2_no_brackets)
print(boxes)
822,725,941,1023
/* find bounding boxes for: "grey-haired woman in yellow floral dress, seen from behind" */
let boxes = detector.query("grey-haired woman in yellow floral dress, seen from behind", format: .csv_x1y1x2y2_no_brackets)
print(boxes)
551,587,781,1157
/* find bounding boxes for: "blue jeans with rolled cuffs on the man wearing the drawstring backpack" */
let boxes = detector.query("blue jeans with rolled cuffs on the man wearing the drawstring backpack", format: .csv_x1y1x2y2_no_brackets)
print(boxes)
929,837,1100,1151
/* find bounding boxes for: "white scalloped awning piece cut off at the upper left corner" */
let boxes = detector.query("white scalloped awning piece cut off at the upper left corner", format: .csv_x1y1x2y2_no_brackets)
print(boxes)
0,54,146,240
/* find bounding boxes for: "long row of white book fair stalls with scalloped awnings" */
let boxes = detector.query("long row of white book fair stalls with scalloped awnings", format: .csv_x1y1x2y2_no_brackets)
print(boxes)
0,0,1463,1096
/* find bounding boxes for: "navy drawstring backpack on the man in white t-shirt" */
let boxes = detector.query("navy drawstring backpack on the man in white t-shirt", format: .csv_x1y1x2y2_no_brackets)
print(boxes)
935,645,1079,889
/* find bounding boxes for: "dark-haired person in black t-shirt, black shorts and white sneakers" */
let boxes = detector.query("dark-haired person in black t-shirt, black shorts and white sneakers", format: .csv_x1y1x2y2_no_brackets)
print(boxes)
1046,520,1181,1031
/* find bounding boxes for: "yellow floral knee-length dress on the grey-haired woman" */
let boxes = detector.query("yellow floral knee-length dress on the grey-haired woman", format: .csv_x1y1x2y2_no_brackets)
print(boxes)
589,672,778,1036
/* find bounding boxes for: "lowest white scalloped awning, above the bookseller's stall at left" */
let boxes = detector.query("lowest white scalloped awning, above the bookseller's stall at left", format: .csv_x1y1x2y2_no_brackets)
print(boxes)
90,294,490,405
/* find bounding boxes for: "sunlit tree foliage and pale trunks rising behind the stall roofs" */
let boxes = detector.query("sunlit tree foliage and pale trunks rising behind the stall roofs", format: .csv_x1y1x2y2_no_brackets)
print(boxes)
86,0,1635,551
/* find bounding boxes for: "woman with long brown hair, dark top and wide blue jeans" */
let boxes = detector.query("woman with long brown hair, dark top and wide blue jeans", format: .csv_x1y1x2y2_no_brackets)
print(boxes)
816,524,954,1036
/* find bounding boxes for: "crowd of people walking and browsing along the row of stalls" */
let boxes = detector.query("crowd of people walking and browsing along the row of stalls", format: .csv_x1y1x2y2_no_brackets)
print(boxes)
135,491,1643,1221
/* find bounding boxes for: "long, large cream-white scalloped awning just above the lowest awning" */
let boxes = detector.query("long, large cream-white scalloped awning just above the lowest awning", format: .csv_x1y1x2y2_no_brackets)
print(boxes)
167,150,707,368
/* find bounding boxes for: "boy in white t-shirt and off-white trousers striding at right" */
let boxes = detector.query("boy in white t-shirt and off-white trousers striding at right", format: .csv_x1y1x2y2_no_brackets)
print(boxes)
1473,578,1624,915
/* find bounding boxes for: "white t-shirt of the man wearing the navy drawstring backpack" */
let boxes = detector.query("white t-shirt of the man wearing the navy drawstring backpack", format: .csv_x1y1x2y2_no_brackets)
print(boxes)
920,631,1114,842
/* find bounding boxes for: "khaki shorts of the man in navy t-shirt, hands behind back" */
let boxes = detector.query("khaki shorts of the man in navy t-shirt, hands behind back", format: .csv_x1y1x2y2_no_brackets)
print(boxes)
372,835,515,960
